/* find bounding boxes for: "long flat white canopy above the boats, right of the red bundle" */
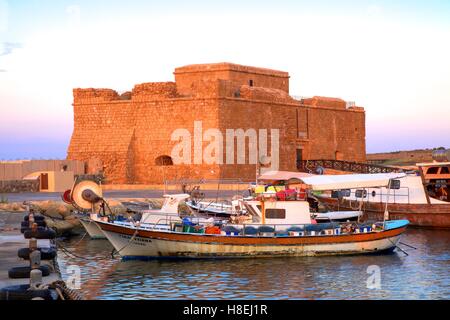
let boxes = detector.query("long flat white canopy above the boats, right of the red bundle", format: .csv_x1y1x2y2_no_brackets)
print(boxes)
302,173,406,191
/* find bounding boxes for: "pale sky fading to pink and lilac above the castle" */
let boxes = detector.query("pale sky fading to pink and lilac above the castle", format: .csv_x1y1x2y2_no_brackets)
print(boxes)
0,0,450,160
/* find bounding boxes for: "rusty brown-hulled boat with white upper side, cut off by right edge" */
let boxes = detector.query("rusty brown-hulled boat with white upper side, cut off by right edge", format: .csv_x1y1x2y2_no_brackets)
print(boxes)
317,154,450,229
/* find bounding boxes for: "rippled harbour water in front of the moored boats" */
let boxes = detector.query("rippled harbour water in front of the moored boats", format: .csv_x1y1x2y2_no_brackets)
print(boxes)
59,228,450,299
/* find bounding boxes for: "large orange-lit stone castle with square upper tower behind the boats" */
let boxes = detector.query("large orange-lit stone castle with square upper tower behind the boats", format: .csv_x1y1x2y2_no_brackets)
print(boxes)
67,63,366,184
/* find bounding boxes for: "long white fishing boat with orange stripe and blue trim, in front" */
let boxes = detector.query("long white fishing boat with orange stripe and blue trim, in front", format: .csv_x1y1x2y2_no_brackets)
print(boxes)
94,175,408,258
